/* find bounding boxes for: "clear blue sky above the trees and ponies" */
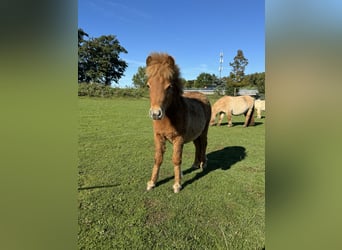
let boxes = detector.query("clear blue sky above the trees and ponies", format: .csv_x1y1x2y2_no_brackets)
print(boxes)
78,0,265,87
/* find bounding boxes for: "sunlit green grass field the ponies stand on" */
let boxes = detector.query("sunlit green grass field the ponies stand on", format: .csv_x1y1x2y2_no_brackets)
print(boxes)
78,98,266,249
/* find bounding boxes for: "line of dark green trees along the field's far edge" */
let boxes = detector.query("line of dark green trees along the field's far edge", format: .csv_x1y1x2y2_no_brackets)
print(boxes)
78,29,265,95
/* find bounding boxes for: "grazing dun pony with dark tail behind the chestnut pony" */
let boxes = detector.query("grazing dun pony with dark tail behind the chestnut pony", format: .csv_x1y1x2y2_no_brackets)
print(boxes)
210,96,254,127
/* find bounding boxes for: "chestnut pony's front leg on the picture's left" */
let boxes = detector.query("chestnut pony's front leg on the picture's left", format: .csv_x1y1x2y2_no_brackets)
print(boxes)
147,135,166,190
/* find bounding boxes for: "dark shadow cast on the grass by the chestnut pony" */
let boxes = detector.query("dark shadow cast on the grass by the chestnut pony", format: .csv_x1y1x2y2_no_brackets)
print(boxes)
156,146,246,189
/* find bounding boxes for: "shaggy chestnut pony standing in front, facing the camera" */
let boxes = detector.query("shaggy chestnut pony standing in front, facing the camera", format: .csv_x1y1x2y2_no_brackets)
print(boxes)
146,53,211,193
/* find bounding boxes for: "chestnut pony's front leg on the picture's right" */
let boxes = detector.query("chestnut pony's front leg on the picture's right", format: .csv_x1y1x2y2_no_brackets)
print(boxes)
172,139,184,193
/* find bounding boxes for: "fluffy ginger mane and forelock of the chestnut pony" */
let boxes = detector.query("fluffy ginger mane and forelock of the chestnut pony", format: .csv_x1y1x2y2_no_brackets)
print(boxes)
146,53,183,93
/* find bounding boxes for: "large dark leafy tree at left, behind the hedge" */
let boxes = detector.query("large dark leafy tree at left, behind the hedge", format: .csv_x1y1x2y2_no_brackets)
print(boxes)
78,29,127,85
